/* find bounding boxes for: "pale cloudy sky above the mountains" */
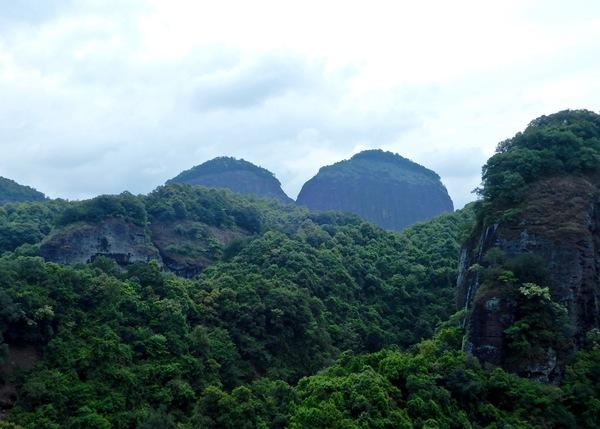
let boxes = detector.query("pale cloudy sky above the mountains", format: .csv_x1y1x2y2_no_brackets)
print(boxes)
0,0,600,208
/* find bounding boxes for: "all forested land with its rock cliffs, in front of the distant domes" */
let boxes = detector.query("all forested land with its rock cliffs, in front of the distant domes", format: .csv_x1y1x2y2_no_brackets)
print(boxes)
0,111,600,429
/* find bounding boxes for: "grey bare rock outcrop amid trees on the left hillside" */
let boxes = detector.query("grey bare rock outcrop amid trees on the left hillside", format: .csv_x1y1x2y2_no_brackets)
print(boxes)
40,218,160,265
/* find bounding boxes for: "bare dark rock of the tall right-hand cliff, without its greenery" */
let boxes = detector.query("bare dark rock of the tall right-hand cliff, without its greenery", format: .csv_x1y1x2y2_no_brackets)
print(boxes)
457,177,600,382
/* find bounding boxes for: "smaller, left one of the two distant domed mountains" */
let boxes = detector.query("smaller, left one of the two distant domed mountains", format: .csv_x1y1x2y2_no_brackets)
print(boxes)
167,157,293,203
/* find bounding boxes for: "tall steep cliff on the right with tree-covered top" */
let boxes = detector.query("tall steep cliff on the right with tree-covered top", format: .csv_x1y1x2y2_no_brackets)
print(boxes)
457,108,600,382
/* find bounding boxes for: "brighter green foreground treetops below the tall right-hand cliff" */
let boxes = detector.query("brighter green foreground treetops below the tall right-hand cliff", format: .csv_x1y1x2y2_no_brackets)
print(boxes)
290,327,580,429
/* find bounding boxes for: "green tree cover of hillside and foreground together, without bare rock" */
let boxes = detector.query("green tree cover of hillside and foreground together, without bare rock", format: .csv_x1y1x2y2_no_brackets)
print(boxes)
0,175,600,429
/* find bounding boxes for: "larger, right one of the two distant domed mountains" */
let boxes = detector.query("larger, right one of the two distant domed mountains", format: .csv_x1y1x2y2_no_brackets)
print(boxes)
297,150,453,230
